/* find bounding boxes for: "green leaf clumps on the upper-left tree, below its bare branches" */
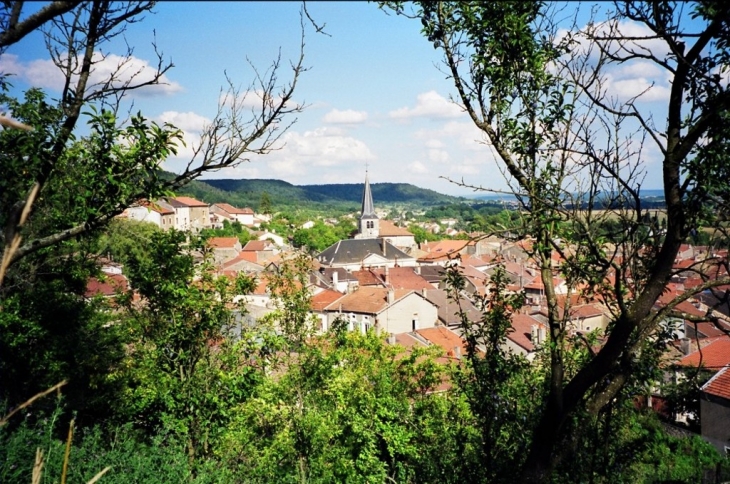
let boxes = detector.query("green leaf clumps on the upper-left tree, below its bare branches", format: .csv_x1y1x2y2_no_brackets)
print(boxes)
0,89,181,246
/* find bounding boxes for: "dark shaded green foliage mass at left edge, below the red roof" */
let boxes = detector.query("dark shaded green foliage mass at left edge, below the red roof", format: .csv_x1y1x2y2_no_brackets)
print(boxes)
0,250,126,420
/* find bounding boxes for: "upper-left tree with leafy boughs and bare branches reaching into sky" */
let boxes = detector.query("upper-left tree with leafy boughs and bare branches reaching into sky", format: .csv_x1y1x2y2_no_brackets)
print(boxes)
0,1,303,273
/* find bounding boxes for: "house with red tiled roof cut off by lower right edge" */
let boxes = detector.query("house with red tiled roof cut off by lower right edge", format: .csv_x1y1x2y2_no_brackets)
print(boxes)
700,366,730,455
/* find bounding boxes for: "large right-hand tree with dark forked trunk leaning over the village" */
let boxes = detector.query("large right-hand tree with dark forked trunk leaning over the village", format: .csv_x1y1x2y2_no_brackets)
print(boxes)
382,1,730,482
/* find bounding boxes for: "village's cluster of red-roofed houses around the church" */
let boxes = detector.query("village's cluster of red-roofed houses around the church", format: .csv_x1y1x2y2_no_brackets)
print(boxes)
87,177,730,458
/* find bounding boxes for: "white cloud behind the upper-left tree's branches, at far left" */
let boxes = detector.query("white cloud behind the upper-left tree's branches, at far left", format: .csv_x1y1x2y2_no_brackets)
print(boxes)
0,52,182,97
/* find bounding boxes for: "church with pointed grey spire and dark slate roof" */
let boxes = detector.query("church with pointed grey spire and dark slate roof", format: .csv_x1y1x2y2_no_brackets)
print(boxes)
316,173,416,270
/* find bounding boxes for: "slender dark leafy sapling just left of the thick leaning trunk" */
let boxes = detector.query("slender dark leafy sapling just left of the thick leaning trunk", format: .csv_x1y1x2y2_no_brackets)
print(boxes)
445,266,544,482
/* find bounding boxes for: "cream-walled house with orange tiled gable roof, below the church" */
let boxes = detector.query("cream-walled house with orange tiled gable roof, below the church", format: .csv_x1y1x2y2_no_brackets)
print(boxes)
325,287,438,334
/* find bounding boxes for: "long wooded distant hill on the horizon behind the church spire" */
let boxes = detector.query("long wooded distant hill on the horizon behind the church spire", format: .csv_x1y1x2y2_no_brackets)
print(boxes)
172,175,463,210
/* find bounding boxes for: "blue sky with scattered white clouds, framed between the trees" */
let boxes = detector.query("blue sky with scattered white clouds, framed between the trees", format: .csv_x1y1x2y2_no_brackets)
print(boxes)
0,2,684,195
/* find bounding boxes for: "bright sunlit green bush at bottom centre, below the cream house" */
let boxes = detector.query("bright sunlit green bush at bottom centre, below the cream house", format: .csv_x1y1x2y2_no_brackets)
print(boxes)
220,329,478,482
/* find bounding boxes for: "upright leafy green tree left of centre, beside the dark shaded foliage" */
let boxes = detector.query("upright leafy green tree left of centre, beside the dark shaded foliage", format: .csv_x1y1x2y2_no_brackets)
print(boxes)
116,231,261,460
